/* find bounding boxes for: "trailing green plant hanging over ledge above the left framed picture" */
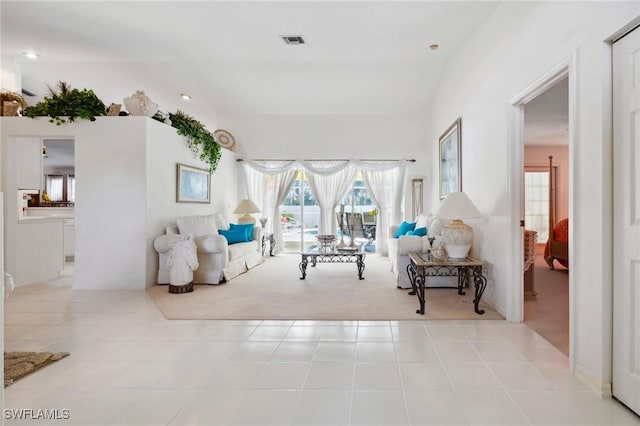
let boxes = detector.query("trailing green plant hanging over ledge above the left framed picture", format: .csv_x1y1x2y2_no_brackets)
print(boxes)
169,110,220,173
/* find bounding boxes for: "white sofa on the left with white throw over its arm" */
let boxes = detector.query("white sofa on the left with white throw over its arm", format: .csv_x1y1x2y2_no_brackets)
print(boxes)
154,215,263,284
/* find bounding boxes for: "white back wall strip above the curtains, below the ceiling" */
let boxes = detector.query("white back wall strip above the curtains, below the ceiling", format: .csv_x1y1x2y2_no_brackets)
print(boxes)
218,109,437,219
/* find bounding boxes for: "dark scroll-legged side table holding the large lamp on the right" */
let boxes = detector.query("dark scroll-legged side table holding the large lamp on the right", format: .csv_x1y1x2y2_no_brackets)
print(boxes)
407,253,487,315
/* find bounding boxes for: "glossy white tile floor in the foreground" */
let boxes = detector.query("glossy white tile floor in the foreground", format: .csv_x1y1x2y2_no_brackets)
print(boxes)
4,285,640,426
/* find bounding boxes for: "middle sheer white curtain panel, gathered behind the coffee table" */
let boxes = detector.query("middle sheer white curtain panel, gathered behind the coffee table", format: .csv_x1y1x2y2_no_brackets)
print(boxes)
302,161,356,235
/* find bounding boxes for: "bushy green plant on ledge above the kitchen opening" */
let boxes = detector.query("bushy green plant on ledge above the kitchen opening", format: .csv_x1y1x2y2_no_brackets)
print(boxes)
24,81,107,126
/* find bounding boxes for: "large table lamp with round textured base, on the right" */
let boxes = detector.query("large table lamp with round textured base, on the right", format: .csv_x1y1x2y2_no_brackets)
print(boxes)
435,192,482,259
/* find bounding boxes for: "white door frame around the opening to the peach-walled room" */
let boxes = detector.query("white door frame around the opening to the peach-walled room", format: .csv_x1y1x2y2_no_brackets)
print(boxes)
506,50,578,362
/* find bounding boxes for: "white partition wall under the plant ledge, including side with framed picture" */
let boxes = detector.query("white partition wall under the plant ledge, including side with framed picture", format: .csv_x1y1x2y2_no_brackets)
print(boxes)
0,117,237,289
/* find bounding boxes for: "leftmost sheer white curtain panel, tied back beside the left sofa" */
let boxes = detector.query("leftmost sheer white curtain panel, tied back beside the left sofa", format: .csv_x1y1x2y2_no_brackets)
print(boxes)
244,160,299,253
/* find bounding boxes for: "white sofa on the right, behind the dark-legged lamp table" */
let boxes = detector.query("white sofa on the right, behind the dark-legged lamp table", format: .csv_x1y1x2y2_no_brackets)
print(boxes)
389,215,458,288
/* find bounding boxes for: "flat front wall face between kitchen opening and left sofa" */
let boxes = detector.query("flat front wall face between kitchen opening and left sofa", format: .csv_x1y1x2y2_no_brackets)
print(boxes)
74,117,148,289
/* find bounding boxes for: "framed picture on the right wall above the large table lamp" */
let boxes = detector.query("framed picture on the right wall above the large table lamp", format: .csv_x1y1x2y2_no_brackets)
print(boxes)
438,118,462,199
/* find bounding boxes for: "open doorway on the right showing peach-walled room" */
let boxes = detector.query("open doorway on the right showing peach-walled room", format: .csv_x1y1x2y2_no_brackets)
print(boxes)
524,76,569,355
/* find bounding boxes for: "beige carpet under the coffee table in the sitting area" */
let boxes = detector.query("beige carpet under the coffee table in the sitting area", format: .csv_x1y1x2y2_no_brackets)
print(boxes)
147,254,504,320
